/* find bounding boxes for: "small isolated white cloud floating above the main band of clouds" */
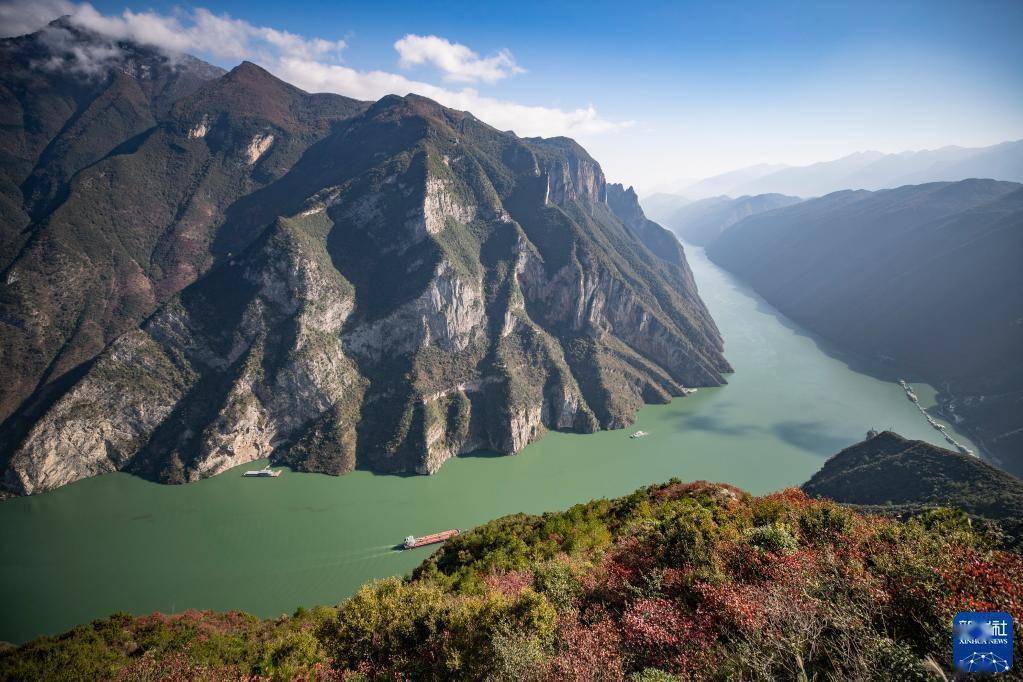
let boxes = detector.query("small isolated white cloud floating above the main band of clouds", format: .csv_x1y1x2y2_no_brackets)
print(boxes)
394,34,526,83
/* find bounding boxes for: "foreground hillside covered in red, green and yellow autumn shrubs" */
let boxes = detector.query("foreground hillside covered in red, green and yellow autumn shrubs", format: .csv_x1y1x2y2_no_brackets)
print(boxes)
6,480,1023,680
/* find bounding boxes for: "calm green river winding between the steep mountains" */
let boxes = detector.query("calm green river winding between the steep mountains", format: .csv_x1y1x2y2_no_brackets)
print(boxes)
0,246,975,642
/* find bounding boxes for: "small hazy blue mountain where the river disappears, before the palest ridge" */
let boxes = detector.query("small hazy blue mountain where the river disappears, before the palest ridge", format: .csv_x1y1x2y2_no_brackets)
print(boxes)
642,194,802,246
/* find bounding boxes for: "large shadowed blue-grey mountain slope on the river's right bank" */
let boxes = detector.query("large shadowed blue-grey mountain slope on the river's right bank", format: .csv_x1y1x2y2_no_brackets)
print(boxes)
707,180,1023,474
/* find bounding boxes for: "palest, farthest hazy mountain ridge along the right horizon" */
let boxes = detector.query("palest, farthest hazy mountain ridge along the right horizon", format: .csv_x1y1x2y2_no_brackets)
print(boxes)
680,140,1023,198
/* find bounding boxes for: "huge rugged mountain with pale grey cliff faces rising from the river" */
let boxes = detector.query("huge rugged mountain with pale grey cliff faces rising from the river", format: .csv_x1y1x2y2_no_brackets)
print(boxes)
6,83,729,494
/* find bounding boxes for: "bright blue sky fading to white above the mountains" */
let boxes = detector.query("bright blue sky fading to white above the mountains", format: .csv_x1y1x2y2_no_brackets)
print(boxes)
7,0,1023,191
